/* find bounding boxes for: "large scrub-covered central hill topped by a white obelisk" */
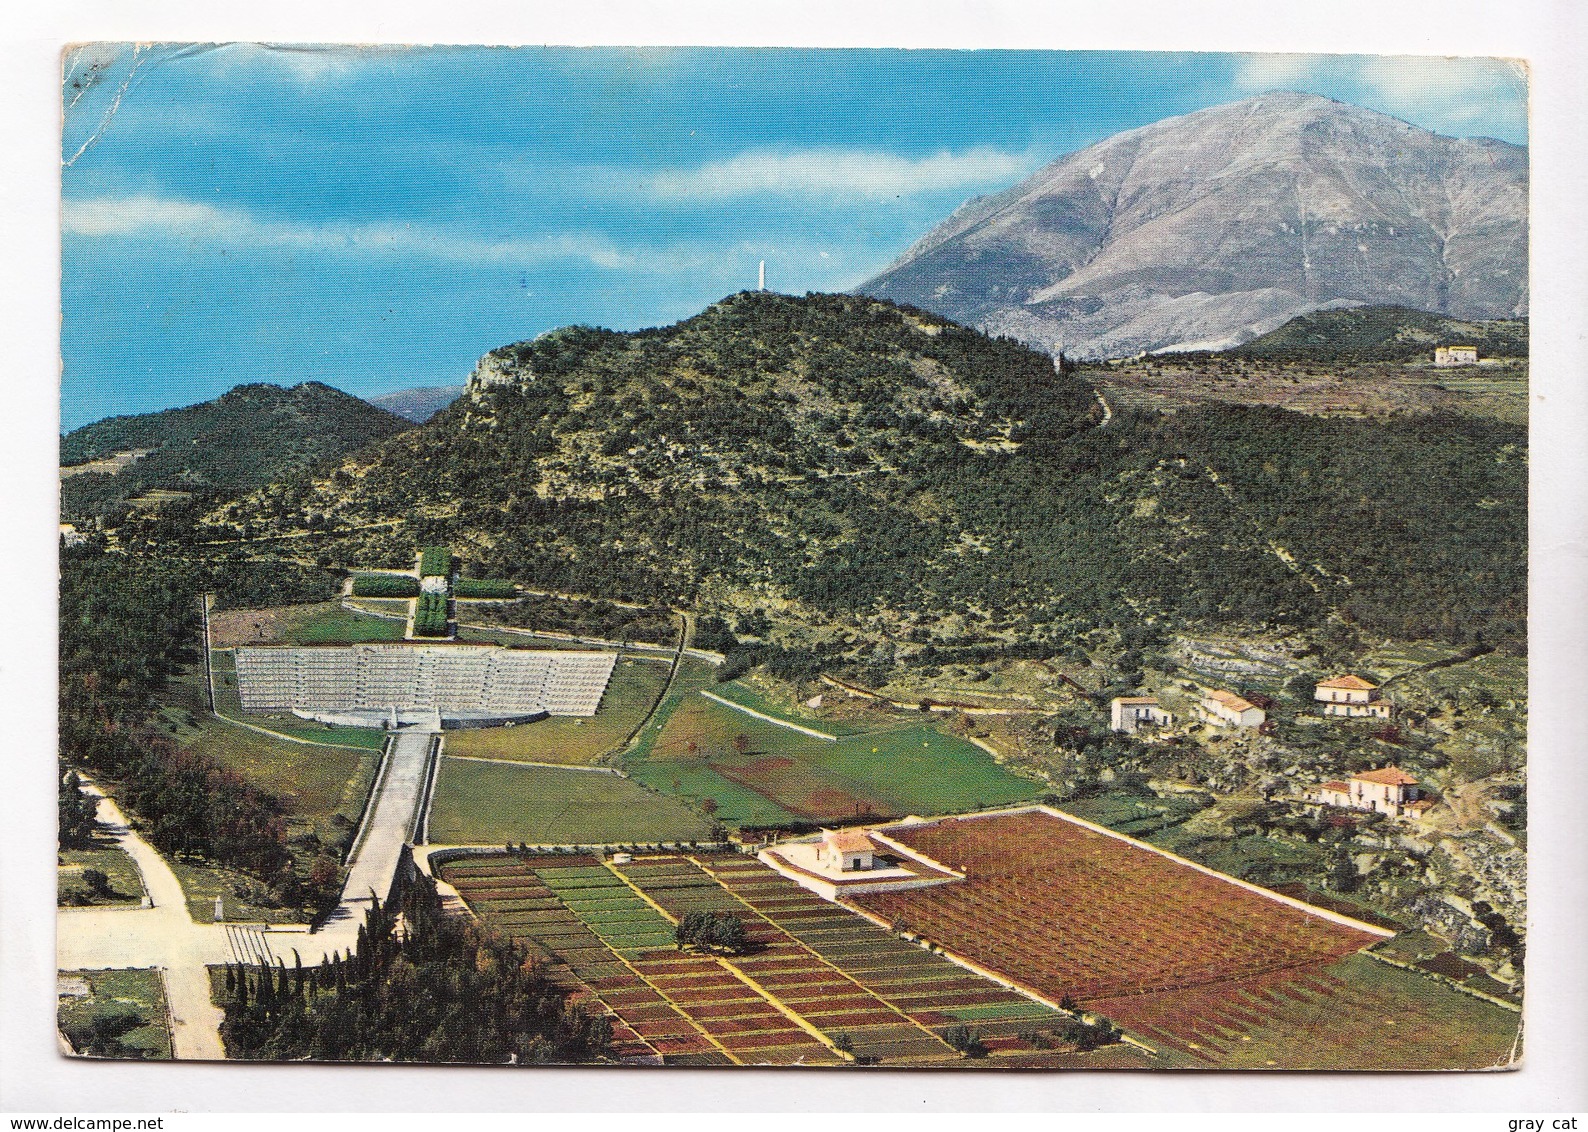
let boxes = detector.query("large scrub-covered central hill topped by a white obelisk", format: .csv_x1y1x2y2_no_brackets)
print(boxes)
185,292,1526,660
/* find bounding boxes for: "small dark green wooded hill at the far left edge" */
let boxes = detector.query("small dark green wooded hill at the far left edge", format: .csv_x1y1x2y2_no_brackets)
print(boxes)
60,381,413,518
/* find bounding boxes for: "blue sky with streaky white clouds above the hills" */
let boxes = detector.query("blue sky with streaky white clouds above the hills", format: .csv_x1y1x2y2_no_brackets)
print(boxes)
62,44,1528,429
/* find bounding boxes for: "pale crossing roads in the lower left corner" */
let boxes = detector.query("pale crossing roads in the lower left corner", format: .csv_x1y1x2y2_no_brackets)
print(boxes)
56,786,232,1061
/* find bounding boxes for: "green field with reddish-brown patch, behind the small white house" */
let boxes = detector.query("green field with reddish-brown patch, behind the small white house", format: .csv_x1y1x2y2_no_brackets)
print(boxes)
627,689,1040,826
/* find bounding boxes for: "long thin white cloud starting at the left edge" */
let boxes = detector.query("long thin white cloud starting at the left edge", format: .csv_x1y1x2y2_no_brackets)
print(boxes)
62,195,672,270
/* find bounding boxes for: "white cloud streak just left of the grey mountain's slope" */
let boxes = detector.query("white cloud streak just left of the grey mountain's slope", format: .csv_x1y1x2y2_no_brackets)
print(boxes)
621,148,1040,202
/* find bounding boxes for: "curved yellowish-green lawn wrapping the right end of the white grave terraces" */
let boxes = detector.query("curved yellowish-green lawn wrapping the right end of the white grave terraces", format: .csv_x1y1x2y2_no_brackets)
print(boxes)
446,657,667,765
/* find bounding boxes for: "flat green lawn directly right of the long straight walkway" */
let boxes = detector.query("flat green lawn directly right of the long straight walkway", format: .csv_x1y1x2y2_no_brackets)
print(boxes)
430,759,711,845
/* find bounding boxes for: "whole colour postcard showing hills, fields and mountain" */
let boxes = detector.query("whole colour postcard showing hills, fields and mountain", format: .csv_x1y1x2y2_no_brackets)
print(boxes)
57,43,1529,1073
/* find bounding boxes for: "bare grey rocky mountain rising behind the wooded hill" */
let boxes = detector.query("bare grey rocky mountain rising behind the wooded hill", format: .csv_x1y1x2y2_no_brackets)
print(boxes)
858,92,1528,359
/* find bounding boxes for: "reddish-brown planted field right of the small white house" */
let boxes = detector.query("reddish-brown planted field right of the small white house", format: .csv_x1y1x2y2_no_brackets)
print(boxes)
854,811,1517,1068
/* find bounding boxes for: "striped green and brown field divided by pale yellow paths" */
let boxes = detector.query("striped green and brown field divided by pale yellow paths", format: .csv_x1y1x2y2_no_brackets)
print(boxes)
443,854,1145,1067
